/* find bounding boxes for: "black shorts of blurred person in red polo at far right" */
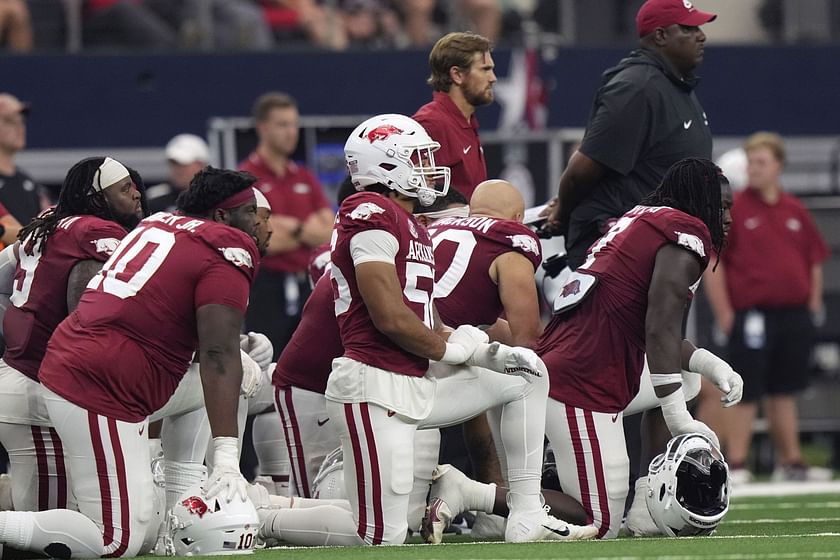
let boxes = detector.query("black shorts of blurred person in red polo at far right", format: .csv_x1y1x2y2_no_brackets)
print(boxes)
728,307,815,401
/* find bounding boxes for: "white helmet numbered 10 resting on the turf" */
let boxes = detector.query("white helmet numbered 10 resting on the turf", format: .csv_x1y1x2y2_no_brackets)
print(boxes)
168,483,260,556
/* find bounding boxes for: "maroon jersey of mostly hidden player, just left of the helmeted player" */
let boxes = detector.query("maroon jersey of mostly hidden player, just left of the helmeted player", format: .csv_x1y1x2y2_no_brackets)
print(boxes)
271,273,344,395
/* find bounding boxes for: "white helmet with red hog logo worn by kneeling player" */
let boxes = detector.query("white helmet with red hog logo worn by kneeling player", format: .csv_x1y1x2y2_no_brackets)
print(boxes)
344,114,449,206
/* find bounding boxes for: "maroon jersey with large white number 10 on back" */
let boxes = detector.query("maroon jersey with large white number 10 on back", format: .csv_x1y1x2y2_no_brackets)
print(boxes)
39,213,258,422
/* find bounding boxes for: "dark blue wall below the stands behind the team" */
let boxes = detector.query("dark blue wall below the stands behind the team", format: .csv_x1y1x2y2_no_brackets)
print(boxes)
0,47,840,148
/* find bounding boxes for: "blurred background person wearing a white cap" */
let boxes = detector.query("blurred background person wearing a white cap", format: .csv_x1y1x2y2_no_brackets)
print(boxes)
146,134,210,214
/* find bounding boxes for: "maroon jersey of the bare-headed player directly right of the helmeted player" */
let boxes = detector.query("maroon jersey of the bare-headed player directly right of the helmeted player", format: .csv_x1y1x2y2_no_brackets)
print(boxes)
429,216,541,327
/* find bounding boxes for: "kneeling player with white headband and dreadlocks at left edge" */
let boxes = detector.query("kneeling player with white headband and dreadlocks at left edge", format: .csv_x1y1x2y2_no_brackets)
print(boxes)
0,157,143,511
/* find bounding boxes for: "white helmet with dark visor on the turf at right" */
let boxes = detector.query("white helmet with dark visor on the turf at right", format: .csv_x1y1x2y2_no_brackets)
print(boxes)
646,433,729,537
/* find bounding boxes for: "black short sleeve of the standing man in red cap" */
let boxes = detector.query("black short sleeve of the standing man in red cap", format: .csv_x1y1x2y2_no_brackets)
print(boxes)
580,81,651,175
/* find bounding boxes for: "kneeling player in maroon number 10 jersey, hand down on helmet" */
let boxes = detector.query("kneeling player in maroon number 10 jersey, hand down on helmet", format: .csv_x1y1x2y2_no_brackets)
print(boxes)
0,167,259,558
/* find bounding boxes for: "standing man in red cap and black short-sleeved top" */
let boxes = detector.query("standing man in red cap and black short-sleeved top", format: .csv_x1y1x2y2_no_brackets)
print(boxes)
546,0,717,533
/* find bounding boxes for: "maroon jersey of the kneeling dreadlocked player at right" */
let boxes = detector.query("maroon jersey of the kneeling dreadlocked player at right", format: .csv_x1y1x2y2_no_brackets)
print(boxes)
536,206,712,412
